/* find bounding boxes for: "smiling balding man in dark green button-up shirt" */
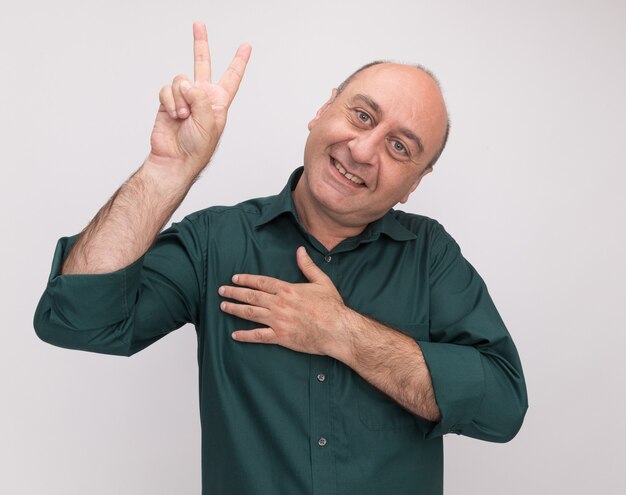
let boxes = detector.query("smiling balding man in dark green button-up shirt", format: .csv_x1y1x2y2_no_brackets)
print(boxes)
35,23,527,495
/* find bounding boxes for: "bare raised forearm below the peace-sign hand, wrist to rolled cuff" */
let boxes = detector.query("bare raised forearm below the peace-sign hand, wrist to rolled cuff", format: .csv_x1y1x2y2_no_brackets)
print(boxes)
62,160,194,274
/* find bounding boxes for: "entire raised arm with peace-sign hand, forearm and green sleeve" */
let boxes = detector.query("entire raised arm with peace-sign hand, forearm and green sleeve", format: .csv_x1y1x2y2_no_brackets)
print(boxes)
34,23,250,355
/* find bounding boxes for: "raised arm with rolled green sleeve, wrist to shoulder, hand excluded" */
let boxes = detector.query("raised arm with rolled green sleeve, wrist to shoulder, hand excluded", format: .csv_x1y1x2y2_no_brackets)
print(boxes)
34,160,202,355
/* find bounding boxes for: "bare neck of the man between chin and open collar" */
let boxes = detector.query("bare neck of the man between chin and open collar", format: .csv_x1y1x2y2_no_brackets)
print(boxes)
292,177,366,251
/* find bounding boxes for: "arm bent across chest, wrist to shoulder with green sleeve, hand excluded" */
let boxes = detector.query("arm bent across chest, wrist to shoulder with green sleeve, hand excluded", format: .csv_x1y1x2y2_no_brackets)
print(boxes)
333,228,528,442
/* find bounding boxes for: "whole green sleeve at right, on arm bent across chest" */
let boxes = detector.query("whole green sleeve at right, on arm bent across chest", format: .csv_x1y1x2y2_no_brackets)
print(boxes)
419,225,528,442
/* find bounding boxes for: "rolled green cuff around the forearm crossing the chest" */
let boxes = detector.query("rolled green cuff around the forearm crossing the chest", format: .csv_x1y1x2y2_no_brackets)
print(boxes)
418,341,485,438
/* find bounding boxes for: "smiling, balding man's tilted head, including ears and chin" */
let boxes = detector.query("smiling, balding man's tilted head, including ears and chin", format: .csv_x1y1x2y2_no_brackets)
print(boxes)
296,64,447,228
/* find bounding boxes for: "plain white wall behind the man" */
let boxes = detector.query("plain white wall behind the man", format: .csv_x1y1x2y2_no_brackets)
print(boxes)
0,0,626,495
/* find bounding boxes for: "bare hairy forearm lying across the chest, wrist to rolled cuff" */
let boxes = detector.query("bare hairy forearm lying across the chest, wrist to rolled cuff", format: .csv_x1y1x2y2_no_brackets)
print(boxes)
331,311,440,422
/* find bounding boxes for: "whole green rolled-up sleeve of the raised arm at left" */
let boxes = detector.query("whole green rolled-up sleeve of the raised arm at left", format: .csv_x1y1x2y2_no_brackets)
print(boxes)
34,218,206,356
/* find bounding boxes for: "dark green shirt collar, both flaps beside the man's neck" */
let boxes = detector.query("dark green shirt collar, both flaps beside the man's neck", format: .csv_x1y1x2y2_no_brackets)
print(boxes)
256,167,417,241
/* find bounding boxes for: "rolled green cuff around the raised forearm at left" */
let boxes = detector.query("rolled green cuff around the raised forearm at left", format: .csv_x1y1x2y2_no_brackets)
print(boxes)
47,235,143,330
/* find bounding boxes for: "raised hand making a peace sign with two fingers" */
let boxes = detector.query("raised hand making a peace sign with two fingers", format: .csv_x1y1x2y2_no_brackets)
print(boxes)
148,22,251,178
